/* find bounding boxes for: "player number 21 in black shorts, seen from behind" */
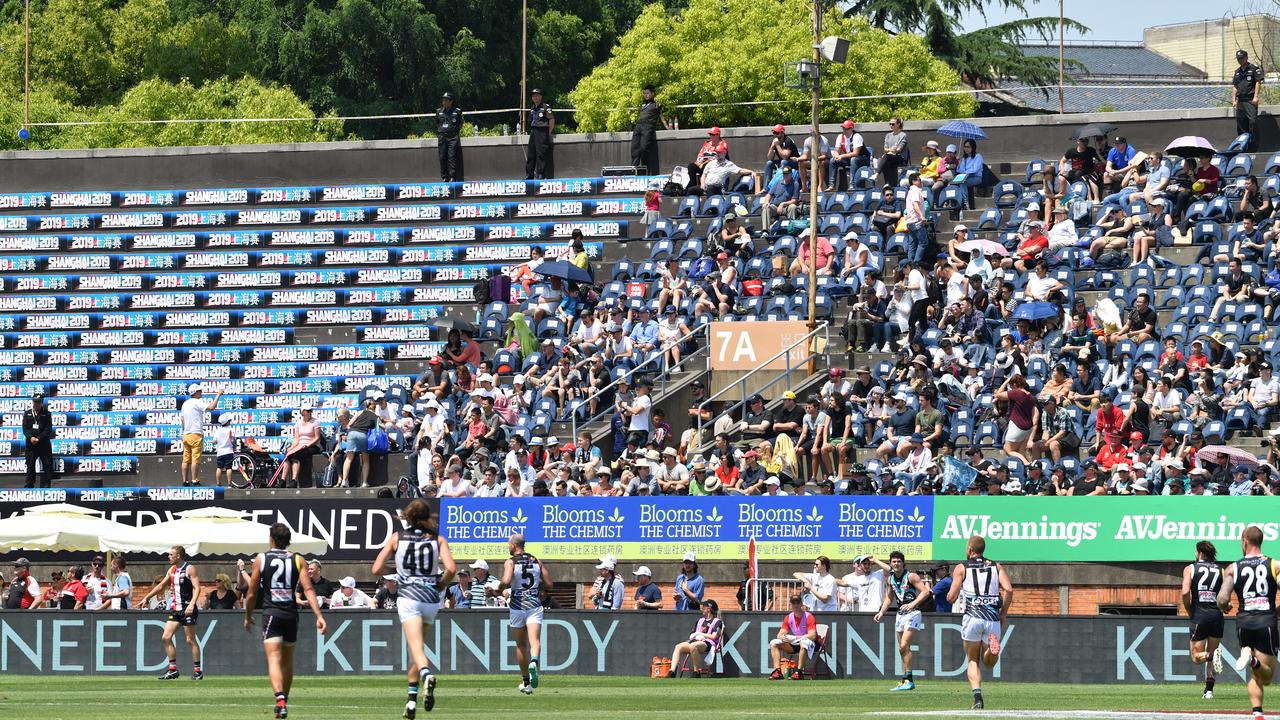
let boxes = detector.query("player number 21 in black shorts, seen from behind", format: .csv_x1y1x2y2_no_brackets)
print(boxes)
244,523,325,719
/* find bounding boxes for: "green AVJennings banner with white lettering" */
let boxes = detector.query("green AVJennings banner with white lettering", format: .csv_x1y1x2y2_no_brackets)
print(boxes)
933,496,1280,562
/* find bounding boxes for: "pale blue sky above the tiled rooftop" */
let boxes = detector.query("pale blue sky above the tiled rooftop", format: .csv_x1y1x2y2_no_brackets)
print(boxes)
963,0,1254,42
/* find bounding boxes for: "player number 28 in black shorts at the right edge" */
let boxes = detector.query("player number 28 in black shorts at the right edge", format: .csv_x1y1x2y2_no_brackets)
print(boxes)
1217,525,1277,720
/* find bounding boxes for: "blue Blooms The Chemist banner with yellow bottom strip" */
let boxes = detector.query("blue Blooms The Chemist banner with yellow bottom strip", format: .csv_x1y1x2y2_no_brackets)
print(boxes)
440,496,934,560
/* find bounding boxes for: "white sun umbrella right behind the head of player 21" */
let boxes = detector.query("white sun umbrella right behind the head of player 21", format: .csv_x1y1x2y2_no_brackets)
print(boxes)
101,507,329,555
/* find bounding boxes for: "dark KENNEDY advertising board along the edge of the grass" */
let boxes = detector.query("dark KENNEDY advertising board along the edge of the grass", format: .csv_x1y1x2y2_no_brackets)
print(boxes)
0,611,1242,683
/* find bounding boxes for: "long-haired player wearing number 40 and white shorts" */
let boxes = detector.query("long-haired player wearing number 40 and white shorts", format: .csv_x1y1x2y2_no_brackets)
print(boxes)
374,500,458,720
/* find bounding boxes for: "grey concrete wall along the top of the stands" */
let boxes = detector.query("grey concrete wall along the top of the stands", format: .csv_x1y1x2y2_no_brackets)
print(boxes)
0,108,1259,192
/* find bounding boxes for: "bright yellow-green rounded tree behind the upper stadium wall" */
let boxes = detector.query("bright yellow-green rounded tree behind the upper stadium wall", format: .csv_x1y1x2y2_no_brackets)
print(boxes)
570,0,975,132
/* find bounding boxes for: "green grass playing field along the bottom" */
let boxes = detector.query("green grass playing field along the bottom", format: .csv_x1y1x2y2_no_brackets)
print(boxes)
0,675,1259,720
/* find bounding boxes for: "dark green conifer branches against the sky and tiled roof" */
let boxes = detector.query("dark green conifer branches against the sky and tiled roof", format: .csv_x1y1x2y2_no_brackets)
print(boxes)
845,0,1089,86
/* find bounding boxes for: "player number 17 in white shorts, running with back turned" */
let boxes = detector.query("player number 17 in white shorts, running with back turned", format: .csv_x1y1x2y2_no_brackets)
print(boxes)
947,536,1014,710
